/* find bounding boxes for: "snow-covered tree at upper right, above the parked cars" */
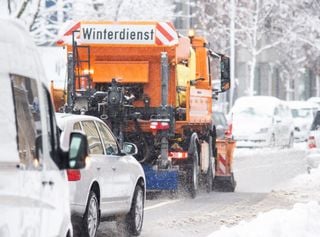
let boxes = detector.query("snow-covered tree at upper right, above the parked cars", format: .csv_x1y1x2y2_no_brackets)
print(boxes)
191,0,320,98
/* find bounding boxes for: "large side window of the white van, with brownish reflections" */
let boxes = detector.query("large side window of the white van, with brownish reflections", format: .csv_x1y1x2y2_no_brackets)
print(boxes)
10,74,42,169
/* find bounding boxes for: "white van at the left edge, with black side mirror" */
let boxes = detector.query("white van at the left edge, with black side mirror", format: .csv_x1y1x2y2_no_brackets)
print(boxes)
0,19,87,237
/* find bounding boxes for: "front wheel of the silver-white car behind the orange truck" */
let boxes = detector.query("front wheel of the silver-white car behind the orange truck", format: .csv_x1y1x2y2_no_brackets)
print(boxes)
117,185,144,236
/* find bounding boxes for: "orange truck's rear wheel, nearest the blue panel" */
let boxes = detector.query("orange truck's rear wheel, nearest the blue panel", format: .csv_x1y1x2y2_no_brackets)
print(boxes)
187,146,199,198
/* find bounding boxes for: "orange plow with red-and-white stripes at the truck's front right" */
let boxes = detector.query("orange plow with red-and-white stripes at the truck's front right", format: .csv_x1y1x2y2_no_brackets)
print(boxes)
212,139,237,192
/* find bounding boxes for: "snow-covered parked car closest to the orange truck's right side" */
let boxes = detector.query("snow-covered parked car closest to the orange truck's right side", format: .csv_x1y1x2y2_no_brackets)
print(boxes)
228,96,294,147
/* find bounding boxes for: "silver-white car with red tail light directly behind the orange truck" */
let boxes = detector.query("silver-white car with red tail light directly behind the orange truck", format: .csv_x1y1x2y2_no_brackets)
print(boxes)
57,113,145,237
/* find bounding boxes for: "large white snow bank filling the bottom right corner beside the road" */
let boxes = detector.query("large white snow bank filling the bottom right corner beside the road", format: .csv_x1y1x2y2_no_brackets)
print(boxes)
208,201,320,237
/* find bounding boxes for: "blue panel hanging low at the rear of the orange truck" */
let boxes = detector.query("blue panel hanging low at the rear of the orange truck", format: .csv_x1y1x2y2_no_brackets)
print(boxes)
142,165,179,191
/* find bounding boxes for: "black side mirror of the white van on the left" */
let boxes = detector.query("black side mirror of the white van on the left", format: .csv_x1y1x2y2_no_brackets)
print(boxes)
68,132,88,169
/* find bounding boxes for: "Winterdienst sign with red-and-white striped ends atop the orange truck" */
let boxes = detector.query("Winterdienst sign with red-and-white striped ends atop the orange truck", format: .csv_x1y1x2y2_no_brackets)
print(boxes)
57,21,178,46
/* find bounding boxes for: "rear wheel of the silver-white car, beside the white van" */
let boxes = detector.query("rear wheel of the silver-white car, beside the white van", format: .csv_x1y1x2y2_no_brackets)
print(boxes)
73,191,99,237
